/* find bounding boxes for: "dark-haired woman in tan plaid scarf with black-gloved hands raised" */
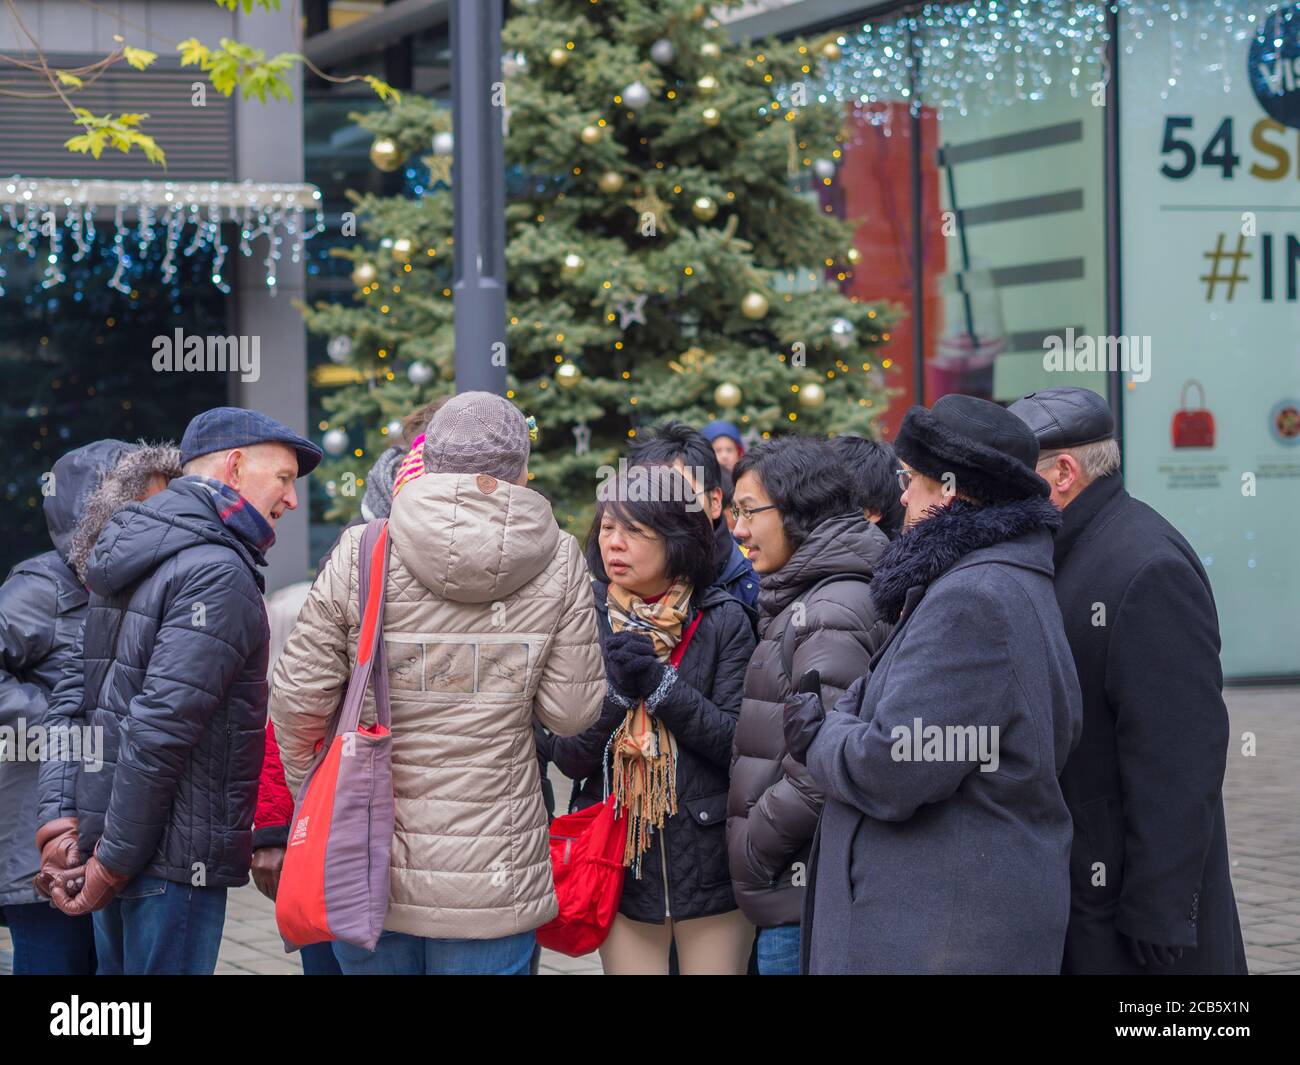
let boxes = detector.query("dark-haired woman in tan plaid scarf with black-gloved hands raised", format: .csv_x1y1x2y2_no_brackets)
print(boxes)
538,466,754,975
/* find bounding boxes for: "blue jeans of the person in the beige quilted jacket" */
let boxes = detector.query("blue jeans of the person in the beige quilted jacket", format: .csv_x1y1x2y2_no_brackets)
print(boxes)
334,932,537,977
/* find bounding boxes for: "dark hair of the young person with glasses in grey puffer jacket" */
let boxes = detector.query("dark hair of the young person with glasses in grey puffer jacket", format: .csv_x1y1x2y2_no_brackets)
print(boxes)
732,436,853,547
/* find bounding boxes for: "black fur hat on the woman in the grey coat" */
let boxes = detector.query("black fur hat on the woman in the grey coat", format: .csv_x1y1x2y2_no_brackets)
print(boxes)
894,395,1050,503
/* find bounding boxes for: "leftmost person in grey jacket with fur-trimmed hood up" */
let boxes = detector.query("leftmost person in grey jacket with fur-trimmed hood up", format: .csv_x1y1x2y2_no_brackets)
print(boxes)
0,440,181,977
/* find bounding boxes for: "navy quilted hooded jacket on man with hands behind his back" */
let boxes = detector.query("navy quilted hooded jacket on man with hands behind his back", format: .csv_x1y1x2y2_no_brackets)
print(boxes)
40,477,269,887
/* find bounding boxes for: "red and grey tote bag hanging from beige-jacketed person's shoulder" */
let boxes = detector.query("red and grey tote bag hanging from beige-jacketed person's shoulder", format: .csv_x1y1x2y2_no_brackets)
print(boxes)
276,521,394,951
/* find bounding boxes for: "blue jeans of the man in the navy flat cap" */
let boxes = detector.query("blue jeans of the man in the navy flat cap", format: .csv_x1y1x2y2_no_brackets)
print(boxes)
95,874,226,977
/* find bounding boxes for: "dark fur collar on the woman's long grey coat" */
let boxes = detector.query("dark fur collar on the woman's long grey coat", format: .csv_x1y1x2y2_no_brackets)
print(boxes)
871,499,1061,623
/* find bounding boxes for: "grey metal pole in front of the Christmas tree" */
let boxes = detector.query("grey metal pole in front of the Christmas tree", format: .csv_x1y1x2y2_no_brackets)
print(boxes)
451,0,506,395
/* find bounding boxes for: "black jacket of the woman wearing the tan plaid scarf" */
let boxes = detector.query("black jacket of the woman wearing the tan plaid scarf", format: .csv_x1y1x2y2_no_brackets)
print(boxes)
542,583,754,925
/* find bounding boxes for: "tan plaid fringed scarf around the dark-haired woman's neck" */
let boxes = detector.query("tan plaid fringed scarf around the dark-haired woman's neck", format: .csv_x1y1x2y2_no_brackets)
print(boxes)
608,579,692,879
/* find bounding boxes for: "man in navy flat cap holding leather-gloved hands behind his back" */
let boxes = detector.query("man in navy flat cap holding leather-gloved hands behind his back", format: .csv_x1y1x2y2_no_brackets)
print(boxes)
42,407,321,974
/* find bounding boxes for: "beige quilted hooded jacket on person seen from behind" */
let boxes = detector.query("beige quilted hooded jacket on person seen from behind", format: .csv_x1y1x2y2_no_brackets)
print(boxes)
270,473,605,939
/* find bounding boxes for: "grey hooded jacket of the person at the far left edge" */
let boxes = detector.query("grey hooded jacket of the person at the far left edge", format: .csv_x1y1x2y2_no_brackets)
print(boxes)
0,440,130,906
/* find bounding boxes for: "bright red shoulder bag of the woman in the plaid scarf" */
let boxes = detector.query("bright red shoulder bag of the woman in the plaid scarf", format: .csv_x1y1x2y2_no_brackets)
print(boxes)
537,611,703,958
